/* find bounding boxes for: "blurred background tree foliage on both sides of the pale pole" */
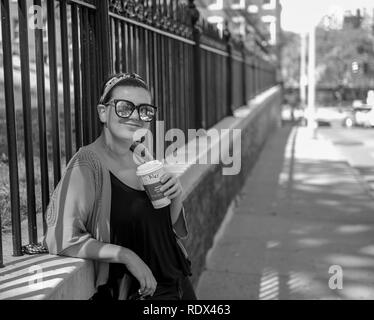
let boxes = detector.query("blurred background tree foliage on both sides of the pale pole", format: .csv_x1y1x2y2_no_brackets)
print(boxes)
282,28,374,88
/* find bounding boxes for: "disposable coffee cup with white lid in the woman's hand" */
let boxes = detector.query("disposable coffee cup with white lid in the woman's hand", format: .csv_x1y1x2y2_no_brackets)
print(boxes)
136,160,171,209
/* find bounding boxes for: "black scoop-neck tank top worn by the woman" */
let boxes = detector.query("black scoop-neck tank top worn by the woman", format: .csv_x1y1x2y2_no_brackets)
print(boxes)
108,173,191,285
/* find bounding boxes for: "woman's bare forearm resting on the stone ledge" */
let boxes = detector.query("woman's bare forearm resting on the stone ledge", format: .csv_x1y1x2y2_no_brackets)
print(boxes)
62,239,134,265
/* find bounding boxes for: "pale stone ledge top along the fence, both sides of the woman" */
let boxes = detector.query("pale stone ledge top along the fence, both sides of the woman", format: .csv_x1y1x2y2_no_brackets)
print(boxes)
0,87,281,300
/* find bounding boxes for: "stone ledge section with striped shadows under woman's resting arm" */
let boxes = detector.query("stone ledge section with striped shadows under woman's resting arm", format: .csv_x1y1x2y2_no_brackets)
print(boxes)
0,255,95,300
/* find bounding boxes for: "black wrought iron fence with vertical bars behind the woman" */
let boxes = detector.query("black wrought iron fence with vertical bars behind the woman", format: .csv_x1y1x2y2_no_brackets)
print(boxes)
0,0,276,266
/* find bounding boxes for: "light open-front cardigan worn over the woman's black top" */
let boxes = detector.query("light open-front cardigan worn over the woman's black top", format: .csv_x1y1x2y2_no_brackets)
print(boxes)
43,136,188,298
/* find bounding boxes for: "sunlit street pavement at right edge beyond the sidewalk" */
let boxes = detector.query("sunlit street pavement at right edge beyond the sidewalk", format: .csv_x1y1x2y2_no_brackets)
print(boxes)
318,127,374,193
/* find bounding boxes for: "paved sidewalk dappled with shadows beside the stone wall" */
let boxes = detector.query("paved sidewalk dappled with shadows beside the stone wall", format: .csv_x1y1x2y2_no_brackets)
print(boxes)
197,127,374,300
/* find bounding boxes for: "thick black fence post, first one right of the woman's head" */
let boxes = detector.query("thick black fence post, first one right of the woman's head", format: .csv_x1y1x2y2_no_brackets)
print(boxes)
188,0,202,129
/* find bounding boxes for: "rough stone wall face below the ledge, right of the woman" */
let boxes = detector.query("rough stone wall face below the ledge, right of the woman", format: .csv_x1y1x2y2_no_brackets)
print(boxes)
184,90,282,285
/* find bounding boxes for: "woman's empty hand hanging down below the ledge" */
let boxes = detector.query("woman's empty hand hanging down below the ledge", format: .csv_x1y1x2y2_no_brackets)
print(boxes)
126,251,157,297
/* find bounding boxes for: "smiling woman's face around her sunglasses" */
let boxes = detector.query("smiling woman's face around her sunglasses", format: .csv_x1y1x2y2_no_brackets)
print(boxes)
99,86,151,140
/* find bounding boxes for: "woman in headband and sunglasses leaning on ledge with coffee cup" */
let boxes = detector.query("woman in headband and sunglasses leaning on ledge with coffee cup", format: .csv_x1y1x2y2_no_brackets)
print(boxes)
44,74,196,300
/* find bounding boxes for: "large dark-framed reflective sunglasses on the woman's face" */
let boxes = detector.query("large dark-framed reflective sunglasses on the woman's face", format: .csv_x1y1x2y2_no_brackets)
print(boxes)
105,99,157,122
